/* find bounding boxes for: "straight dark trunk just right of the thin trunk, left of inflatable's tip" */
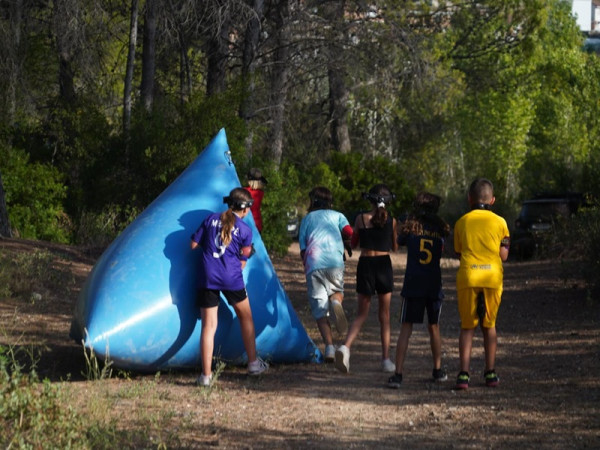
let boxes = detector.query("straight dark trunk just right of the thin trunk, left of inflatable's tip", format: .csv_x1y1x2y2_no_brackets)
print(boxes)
140,0,159,112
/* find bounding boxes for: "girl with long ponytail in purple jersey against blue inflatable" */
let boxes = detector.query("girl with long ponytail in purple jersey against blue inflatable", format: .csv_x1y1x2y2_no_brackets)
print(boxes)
191,188,268,386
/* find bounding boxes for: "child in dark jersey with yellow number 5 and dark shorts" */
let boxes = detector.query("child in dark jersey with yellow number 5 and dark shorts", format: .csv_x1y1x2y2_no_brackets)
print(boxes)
388,192,450,388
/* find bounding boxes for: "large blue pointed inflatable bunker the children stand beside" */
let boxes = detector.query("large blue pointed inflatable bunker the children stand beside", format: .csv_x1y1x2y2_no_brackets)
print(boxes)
70,129,322,371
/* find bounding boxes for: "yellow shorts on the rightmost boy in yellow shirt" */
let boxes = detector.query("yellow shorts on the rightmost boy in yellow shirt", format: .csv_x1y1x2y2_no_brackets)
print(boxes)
456,288,502,329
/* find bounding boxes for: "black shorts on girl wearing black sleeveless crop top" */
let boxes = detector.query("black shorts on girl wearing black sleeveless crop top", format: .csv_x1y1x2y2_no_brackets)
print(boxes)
356,255,394,295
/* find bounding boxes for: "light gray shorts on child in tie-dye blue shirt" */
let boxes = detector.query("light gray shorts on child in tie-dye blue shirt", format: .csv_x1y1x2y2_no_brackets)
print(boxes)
306,267,344,320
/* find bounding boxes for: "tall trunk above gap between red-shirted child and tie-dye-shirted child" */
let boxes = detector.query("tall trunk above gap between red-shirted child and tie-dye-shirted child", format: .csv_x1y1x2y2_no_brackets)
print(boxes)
270,0,290,167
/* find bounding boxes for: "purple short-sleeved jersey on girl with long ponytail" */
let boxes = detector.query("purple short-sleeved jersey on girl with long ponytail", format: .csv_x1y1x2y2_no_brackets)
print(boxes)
192,213,252,291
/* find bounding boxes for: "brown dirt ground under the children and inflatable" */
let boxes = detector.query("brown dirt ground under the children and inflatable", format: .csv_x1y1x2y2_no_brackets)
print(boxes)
0,240,600,449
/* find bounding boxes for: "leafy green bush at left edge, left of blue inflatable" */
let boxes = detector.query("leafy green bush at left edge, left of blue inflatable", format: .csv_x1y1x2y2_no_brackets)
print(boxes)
0,146,70,242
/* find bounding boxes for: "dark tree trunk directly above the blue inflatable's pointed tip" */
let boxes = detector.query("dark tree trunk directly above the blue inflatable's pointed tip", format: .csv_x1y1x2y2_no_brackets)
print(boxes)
206,10,231,96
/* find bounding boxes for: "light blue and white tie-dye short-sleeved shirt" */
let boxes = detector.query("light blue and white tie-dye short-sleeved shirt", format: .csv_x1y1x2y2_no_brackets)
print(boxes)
298,209,350,275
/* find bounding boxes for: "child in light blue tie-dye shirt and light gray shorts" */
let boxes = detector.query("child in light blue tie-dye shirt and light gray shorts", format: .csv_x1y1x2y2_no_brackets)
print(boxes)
298,186,352,362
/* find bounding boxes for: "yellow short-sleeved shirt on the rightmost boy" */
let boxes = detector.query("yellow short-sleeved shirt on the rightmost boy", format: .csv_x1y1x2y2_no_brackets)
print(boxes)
454,209,509,289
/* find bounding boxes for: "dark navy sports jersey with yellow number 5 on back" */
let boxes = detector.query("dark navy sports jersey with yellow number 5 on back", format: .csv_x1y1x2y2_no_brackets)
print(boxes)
398,225,444,298
